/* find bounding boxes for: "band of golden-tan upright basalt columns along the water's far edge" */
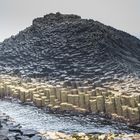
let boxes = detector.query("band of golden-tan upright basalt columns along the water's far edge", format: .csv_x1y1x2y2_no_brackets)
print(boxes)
0,75,140,124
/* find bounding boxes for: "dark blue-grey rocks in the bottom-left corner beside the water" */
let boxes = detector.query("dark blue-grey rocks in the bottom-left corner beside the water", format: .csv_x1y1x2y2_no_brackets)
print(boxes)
0,112,45,140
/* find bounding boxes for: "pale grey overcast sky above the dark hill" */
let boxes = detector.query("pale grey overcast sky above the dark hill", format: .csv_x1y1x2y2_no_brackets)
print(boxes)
0,0,140,42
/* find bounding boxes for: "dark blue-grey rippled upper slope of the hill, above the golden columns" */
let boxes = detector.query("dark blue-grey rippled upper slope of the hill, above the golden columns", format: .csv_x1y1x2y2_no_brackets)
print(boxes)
0,13,140,82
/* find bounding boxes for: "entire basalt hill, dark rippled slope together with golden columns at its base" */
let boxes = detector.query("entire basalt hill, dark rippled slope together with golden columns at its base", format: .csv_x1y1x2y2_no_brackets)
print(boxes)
0,13,140,139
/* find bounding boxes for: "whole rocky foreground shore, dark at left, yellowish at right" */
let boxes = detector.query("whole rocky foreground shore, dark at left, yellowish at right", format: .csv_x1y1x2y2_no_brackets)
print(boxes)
0,112,140,140
